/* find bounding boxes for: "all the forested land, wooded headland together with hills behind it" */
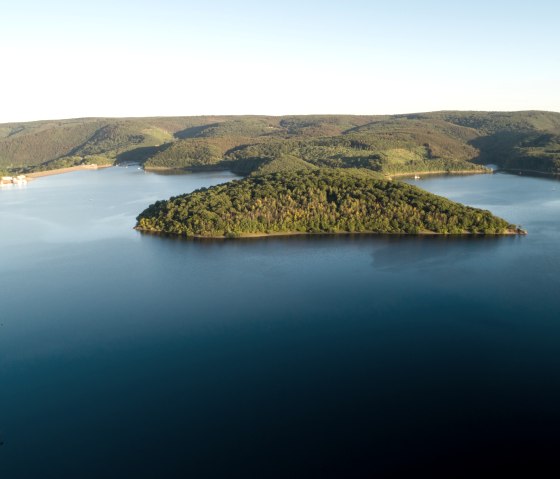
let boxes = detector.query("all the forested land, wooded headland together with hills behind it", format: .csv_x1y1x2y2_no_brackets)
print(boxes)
0,111,548,237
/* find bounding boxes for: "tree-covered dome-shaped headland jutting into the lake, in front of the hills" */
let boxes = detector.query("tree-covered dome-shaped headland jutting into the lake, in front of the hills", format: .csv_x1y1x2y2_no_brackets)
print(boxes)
136,168,524,238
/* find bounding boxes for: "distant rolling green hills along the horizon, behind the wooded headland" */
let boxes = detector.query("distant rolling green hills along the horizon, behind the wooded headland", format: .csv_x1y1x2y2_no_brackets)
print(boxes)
0,111,560,175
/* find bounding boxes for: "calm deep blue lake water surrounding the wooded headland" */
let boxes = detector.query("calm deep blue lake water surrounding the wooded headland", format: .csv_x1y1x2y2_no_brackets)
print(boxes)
0,167,560,479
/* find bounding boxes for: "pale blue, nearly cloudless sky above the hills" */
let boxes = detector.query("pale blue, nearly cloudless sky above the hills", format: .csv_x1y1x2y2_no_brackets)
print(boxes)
0,0,560,122
